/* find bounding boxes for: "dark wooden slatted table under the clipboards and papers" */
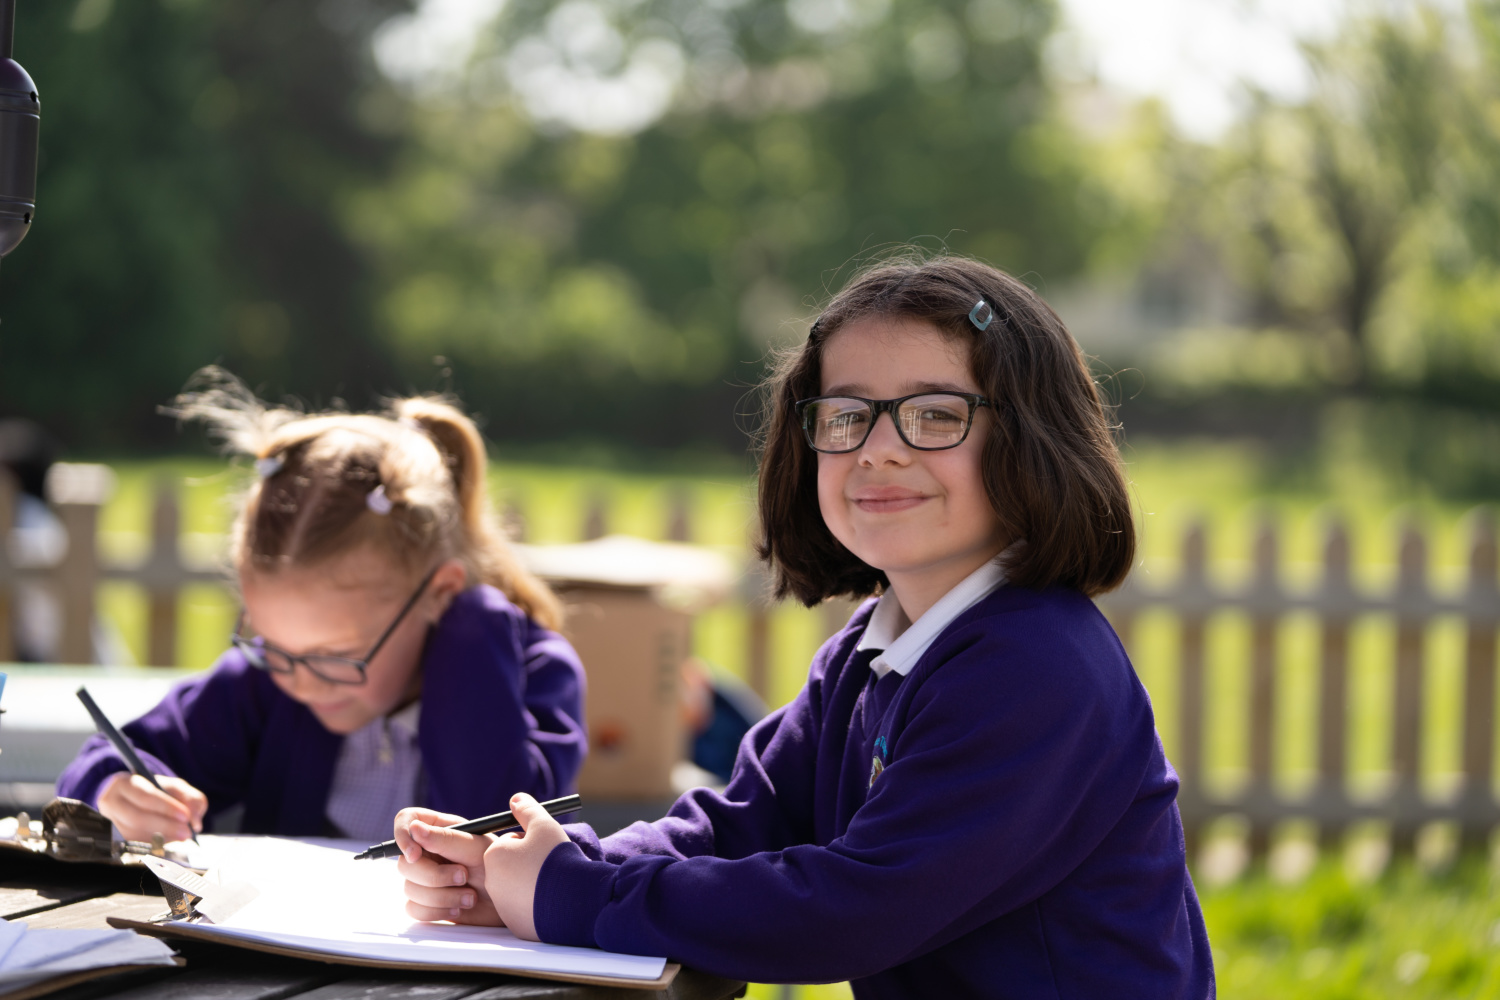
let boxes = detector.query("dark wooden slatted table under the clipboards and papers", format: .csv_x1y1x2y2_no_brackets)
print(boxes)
0,852,746,1000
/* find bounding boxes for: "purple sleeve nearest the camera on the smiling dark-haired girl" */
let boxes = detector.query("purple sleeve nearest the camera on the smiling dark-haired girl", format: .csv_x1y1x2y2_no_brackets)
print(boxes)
534,617,1155,982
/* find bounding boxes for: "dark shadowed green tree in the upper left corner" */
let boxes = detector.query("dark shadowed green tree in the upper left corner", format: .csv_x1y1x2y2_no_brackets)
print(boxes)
0,0,410,448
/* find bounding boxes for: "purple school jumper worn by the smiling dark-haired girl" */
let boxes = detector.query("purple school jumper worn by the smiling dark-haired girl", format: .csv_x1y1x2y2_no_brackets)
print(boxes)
533,586,1214,1000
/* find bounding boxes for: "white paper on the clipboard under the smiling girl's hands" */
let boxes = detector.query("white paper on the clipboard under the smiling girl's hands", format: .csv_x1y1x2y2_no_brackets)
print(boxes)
178,837,666,979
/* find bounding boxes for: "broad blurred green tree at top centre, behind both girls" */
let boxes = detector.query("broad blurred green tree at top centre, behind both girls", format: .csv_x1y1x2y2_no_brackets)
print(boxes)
348,0,1103,447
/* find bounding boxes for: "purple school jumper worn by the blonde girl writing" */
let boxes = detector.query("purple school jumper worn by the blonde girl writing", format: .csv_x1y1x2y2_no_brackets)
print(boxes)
57,586,588,837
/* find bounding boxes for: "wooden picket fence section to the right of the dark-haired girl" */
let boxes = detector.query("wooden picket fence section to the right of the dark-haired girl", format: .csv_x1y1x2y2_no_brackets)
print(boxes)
1101,511,1500,853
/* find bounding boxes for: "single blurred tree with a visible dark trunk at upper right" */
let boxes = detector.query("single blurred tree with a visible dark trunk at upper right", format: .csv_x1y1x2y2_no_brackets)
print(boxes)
1215,9,1458,387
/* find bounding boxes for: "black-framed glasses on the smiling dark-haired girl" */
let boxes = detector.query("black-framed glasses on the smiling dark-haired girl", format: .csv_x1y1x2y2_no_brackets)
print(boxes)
797,393,990,454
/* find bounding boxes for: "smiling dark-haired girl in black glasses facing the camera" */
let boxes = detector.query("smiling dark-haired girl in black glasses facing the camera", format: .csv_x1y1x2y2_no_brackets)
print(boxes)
396,258,1214,1000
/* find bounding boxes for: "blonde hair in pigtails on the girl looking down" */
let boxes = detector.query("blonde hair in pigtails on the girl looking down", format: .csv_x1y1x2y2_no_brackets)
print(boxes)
164,367,563,628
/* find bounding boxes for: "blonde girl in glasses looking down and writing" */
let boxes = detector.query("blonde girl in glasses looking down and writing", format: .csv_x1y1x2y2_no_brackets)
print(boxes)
57,369,587,841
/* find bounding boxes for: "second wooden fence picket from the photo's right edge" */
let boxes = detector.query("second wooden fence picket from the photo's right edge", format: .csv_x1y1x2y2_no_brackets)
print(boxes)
1391,523,1428,853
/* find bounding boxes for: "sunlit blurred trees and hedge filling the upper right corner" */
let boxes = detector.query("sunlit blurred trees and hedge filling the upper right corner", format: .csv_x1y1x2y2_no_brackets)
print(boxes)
1094,0,1500,496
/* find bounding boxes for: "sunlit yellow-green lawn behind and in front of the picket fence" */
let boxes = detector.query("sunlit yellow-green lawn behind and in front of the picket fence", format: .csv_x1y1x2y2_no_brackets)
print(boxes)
87,444,1500,1000
